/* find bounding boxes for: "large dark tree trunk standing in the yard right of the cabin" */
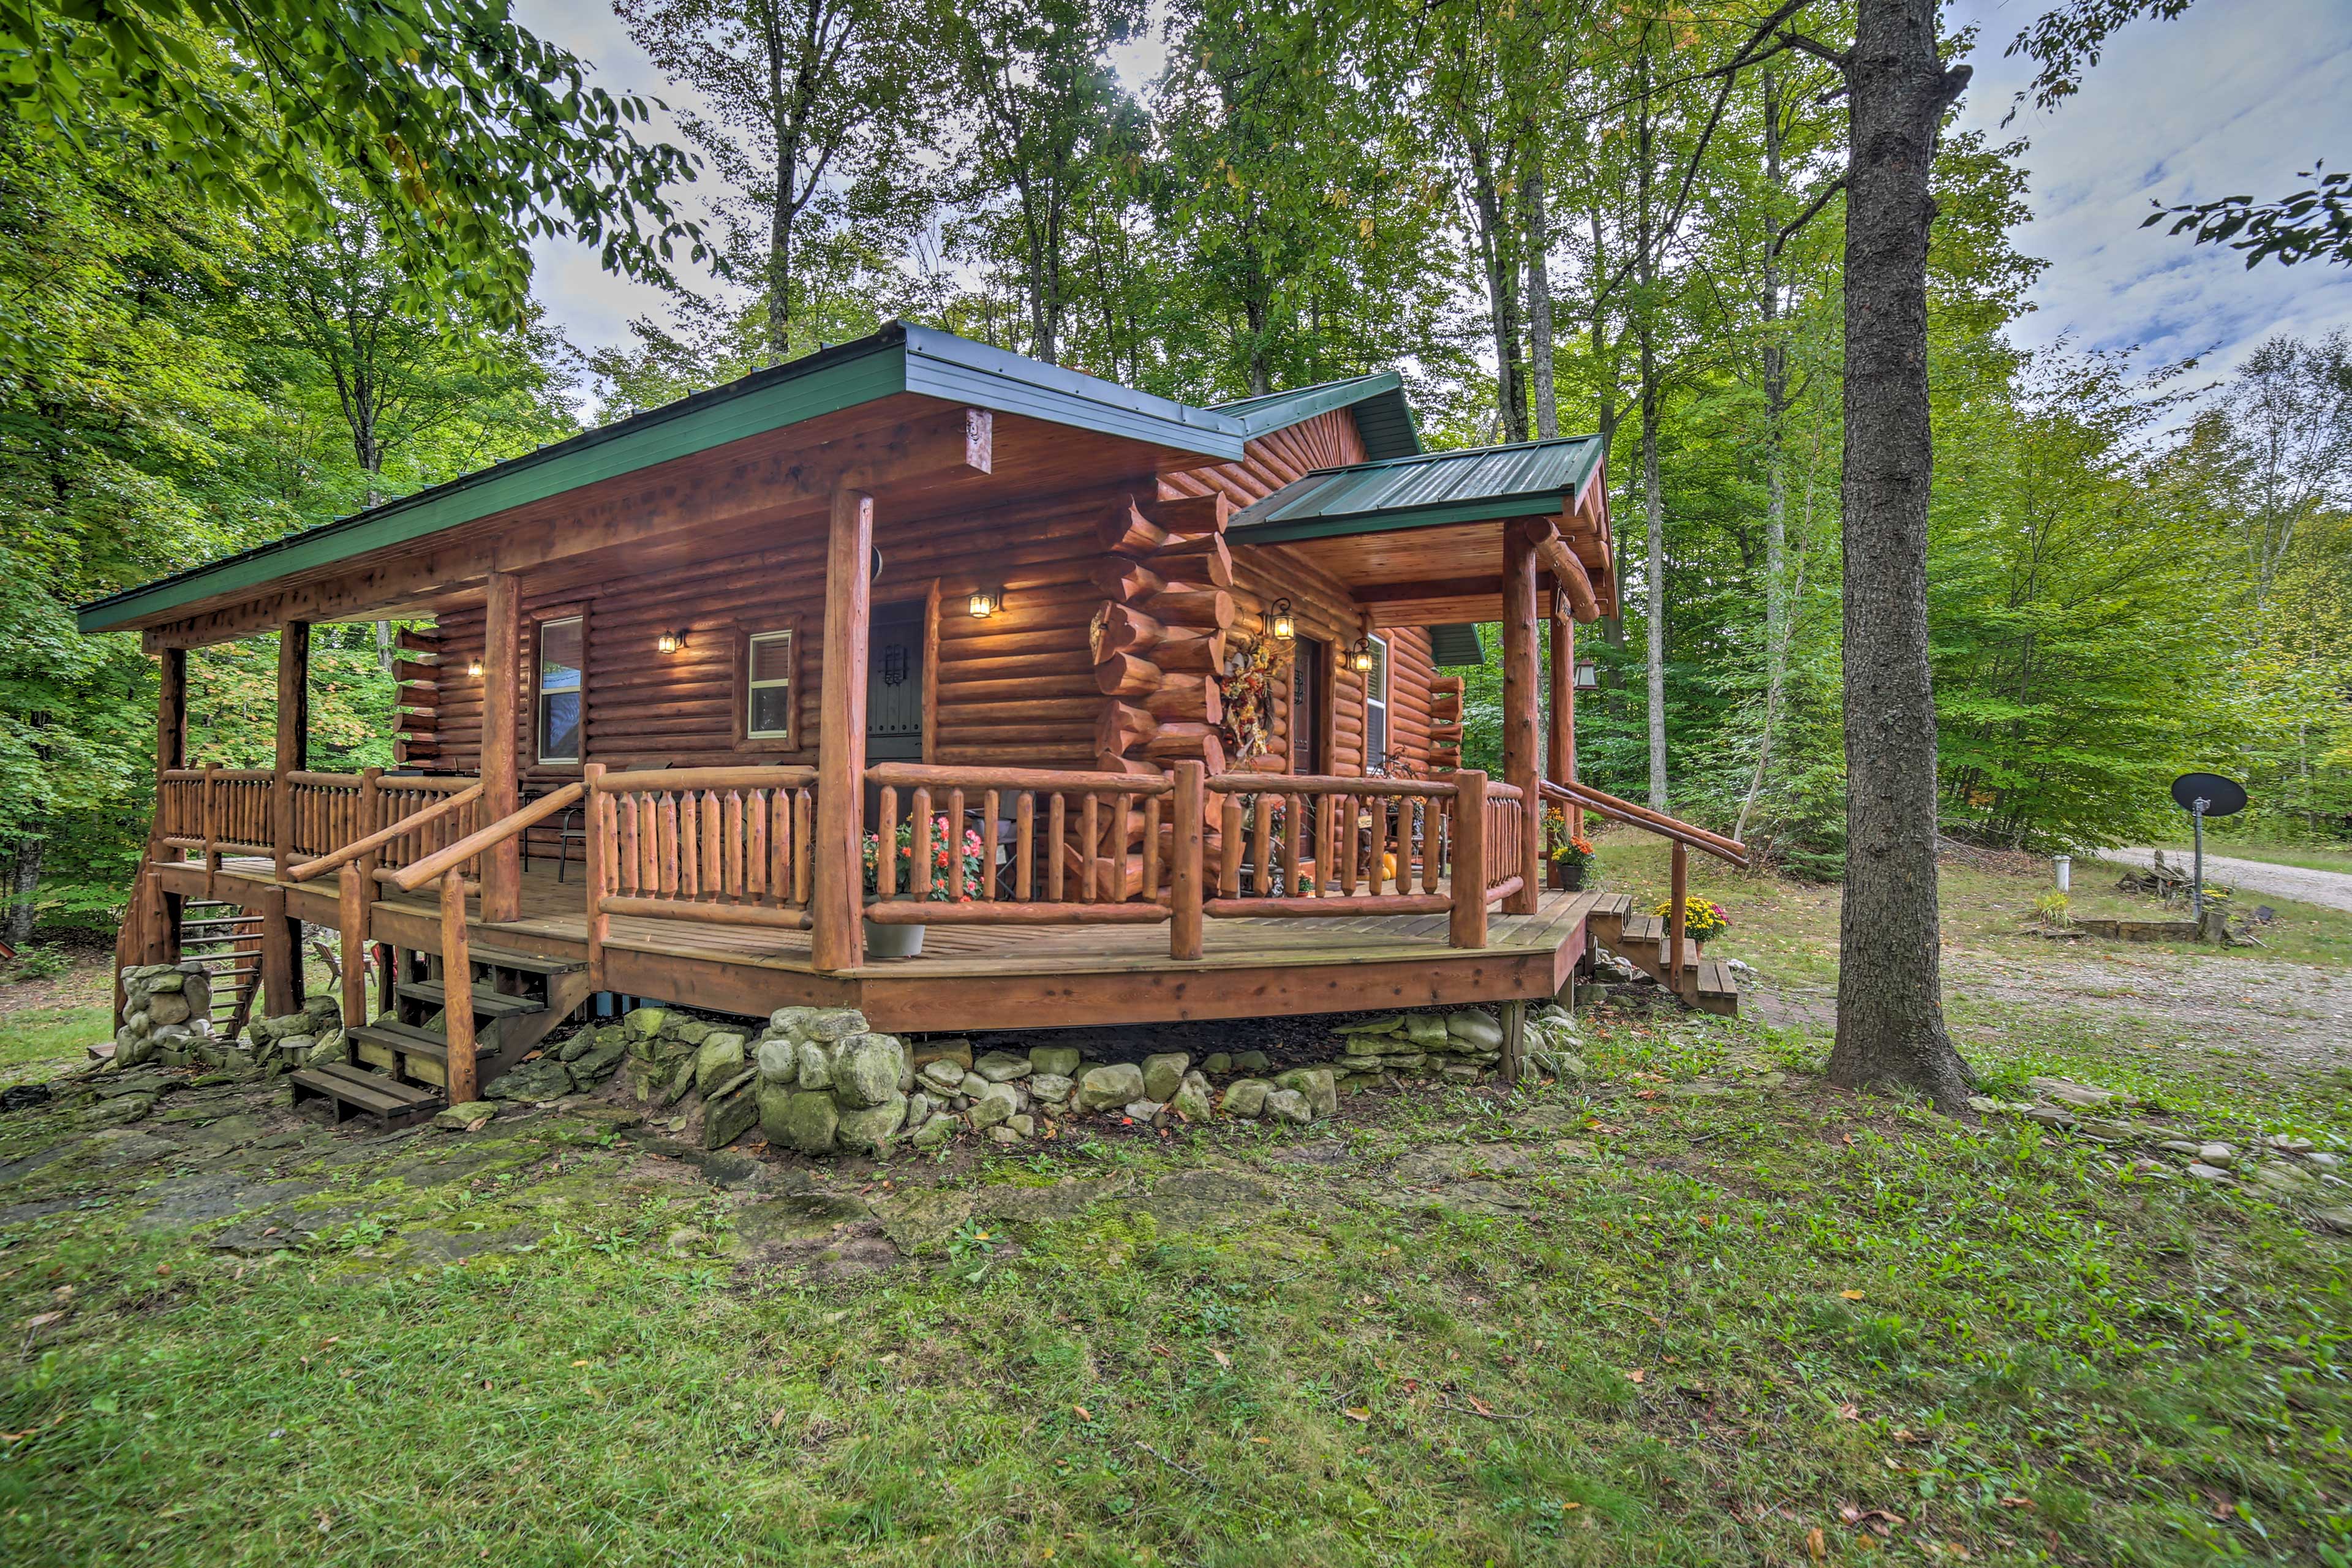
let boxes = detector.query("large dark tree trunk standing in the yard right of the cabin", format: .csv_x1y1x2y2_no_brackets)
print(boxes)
1830,0,1969,1112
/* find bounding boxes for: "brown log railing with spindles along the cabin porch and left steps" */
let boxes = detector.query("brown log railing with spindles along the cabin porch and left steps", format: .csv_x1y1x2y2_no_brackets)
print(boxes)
157,762,1580,992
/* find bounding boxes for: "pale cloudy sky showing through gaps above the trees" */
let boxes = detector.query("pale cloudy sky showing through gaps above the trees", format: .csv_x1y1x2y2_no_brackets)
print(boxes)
515,0,2352,411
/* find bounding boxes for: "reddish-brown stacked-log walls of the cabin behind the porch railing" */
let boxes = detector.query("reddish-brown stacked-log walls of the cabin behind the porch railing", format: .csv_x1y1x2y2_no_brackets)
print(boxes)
400,412,1439,809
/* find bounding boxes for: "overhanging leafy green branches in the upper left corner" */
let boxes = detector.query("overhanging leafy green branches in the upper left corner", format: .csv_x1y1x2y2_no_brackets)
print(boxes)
0,0,703,317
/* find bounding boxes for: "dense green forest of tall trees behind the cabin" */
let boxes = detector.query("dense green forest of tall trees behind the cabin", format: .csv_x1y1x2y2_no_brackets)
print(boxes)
0,0,2352,943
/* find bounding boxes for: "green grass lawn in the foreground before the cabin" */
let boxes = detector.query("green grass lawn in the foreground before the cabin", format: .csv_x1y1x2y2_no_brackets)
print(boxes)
0,879,2352,1568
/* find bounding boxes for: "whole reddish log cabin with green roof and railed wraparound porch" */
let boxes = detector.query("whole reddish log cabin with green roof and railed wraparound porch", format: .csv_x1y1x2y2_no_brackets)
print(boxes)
80,322,1738,1114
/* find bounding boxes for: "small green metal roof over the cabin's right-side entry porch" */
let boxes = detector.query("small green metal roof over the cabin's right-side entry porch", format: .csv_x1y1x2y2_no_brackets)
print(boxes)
1232,435,1602,545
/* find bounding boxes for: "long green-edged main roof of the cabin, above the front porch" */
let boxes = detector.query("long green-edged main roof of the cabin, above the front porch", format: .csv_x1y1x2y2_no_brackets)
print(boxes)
91,322,1419,632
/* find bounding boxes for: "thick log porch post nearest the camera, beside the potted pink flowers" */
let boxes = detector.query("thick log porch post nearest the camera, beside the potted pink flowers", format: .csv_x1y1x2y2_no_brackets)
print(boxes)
809,484,875,971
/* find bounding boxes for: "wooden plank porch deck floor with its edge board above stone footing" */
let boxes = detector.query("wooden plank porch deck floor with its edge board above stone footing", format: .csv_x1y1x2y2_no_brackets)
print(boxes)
155,858,1599,1032
